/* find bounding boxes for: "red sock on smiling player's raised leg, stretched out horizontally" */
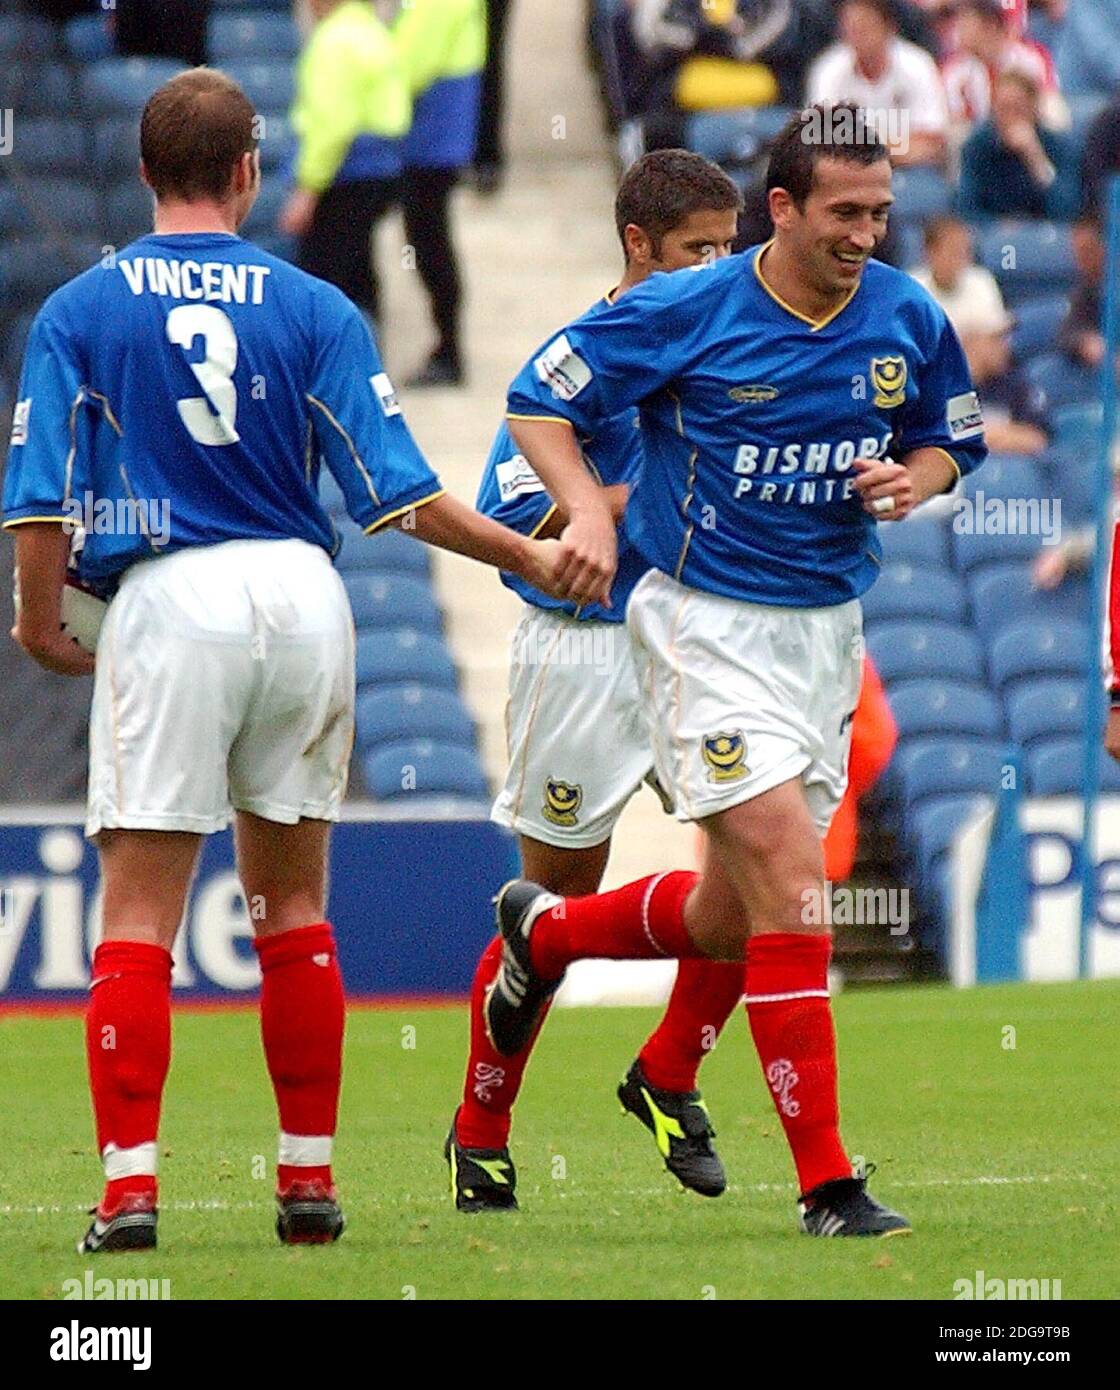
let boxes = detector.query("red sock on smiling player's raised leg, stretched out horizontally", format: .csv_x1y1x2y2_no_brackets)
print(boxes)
531,869,707,980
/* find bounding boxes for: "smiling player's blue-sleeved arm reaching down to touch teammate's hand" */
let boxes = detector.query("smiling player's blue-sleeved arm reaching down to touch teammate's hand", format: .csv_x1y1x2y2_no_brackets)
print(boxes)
507,283,692,606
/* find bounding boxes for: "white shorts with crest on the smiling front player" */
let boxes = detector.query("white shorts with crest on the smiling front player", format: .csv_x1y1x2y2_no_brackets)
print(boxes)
627,570,863,834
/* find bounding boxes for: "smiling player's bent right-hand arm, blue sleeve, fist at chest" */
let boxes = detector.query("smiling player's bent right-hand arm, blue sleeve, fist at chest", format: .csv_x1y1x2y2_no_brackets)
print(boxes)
853,306,988,521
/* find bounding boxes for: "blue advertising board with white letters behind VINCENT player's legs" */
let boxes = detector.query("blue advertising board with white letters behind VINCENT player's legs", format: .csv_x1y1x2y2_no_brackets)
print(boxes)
0,806,517,1006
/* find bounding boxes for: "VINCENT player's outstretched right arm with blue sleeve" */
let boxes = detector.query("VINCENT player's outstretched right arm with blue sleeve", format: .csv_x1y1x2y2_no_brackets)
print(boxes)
307,304,566,596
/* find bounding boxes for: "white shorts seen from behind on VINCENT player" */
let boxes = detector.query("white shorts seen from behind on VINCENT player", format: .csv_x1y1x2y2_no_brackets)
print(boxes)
86,539,354,835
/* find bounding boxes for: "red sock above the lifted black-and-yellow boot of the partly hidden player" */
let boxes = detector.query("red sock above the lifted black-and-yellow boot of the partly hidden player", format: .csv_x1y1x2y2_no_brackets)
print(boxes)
638,960,743,1091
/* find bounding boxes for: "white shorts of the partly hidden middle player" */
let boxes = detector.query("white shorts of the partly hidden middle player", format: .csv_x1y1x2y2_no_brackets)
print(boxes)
491,605,653,849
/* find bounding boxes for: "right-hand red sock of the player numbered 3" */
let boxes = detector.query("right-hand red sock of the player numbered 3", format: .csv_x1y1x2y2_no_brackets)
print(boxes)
253,922,345,1191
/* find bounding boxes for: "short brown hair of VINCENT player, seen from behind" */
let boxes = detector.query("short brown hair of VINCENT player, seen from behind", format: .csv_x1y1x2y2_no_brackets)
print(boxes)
140,68,257,202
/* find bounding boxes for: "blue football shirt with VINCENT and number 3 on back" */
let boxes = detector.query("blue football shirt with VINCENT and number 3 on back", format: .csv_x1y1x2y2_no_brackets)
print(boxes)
3,232,442,591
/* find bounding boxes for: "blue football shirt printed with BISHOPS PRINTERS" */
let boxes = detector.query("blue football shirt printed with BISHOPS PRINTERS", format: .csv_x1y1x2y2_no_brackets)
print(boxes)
509,246,987,607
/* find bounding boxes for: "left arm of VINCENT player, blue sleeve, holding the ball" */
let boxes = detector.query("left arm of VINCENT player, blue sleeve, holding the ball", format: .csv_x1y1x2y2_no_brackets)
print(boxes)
4,303,93,676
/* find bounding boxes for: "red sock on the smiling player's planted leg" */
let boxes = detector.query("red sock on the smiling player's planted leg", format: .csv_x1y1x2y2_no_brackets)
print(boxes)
746,931,852,1193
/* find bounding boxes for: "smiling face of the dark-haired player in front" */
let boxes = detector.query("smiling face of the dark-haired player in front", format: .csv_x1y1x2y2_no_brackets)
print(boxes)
770,156,892,299
